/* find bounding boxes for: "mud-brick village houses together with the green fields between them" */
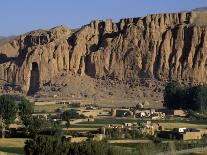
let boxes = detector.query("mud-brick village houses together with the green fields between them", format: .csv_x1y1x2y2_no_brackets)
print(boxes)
27,101,207,143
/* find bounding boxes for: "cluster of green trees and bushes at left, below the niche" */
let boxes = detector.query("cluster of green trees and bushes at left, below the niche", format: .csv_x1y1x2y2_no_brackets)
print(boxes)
0,95,61,137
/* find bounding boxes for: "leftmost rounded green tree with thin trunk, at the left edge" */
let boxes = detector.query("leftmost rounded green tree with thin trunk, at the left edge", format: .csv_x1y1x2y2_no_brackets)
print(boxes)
0,95,17,138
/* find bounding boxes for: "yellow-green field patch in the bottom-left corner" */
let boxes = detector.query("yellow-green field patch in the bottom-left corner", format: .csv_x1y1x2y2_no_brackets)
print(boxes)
0,138,26,155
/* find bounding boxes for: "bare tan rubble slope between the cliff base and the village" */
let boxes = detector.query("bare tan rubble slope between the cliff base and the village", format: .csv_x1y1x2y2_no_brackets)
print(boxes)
2,73,165,107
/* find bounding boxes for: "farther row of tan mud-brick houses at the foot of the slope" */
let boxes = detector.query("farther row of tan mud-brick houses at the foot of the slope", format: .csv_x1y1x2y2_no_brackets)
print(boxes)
34,101,186,120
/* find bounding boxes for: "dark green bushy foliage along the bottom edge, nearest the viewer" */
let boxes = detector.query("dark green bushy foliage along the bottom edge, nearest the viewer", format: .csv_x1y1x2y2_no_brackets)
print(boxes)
24,136,130,155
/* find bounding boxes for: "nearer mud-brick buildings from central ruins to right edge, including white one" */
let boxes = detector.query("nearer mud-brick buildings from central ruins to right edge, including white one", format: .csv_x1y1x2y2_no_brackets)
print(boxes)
101,121,207,140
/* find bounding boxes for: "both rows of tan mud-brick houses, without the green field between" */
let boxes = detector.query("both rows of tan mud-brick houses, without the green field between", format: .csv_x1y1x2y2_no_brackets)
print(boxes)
33,102,207,142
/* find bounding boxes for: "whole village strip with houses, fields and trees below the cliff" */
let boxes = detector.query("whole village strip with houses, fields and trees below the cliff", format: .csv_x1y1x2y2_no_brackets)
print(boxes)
0,88,207,153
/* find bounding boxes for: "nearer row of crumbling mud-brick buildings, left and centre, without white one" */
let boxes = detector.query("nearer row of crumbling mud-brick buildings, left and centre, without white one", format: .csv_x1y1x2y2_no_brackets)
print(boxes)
61,121,159,143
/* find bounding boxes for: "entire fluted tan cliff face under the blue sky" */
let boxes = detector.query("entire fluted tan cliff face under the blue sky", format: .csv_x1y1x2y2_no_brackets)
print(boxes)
0,12,207,93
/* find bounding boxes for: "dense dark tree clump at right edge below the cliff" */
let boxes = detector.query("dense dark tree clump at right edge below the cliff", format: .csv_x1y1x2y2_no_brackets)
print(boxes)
164,81,207,113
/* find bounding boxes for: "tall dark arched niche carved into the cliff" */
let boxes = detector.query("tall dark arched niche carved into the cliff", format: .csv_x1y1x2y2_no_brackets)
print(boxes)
27,62,39,96
